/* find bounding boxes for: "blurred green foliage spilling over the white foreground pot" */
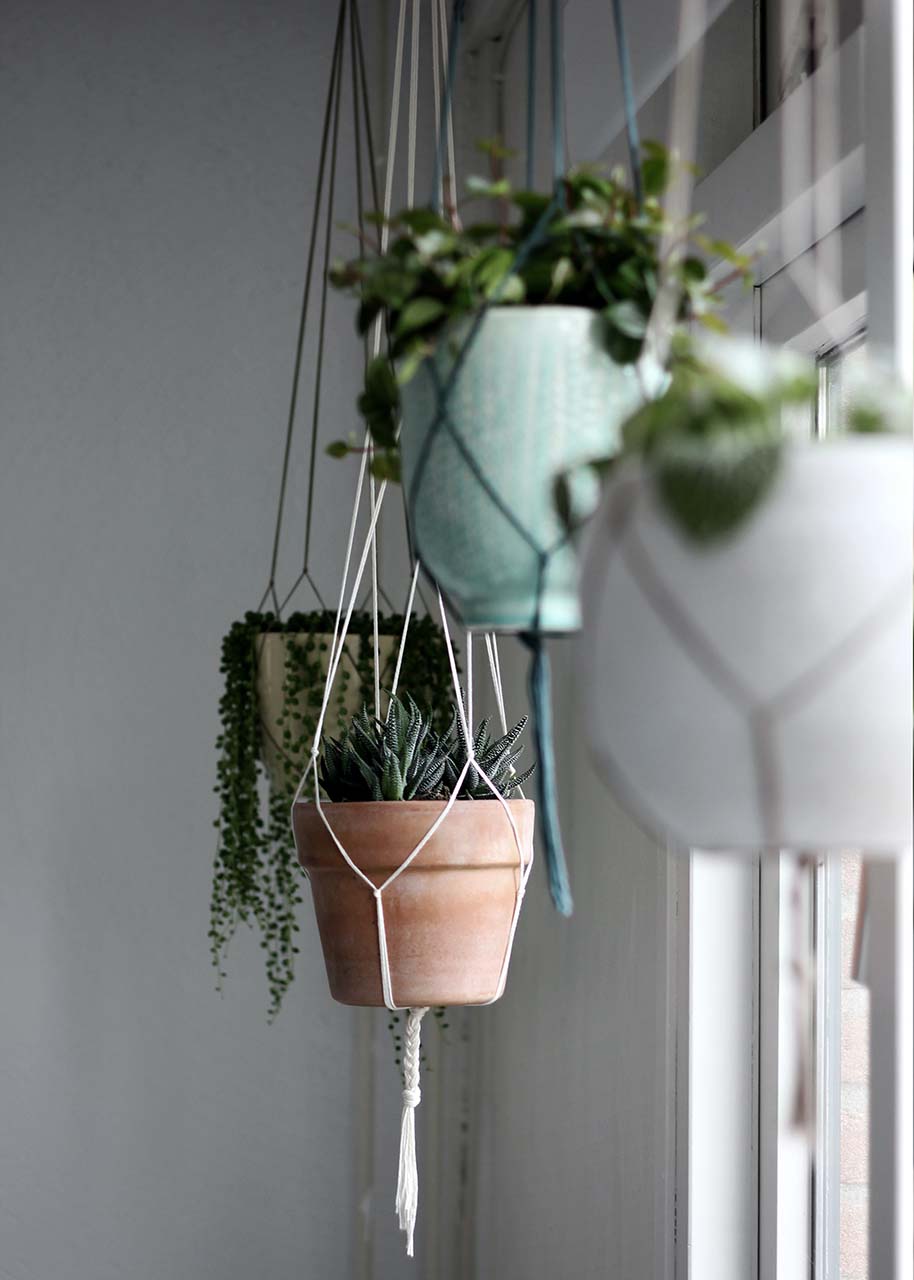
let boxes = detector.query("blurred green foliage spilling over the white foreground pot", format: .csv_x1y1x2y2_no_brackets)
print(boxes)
556,334,910,545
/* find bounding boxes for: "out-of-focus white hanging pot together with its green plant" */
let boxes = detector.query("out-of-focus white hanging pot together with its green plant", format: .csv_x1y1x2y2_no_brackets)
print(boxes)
573,338,911,855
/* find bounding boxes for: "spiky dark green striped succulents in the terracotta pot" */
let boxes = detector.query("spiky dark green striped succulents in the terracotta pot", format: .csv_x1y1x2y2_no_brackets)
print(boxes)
319,694,533,803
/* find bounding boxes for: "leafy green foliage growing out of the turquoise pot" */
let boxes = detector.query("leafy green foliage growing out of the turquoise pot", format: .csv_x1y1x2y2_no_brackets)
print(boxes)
328,142,749,480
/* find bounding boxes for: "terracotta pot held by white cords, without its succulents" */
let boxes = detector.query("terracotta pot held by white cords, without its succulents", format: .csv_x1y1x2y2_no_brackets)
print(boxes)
292,800,534,1006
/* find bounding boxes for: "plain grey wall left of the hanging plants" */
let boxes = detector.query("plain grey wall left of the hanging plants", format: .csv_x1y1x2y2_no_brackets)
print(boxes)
0,0,370,1280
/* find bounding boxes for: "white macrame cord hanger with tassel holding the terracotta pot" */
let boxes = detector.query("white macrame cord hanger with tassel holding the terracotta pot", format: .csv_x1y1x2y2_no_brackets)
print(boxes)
292,0,533,1257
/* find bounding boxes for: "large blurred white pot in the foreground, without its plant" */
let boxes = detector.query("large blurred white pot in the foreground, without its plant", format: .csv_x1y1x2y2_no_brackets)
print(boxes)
581,436,911,852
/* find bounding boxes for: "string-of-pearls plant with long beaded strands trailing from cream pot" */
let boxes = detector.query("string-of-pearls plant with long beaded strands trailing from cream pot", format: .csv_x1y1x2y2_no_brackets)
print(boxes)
209,611,452,1019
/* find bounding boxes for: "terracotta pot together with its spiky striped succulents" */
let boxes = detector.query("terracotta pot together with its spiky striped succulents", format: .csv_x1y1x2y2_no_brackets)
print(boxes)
292,696,534,1007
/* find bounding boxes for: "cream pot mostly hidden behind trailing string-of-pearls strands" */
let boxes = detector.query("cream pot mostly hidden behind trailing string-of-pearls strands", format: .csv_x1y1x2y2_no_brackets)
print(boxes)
257,631,399,788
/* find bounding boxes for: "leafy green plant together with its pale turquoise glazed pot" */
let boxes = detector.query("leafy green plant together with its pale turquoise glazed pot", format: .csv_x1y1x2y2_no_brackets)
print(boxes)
330,145,748,631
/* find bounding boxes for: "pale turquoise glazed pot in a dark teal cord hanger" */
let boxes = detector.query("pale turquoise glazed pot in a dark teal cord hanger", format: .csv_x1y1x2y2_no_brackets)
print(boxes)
401,306,643,632
